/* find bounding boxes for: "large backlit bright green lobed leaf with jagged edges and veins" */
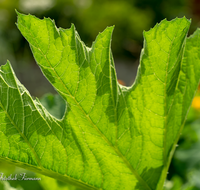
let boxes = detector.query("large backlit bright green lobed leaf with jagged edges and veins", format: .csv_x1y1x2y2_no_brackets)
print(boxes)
0,13,200,190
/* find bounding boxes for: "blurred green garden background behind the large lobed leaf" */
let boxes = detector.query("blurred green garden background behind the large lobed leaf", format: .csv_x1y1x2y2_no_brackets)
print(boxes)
0,0,200,190
